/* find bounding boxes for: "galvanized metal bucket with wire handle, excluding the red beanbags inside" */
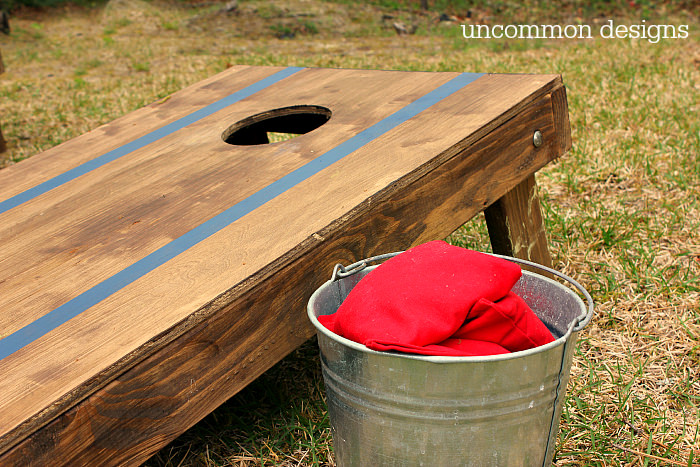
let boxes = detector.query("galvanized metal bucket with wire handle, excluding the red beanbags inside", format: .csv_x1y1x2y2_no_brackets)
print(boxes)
307,253,593,467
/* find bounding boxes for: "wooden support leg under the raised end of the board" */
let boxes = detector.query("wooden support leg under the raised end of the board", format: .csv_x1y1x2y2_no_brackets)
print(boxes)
484,175,552,267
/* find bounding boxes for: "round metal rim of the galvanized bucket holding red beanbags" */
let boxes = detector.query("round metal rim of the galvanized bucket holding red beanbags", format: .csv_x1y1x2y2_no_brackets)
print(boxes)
306,252,593,364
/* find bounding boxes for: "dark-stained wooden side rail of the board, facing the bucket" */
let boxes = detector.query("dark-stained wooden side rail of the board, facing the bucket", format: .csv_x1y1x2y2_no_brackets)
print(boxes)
0,89,557,465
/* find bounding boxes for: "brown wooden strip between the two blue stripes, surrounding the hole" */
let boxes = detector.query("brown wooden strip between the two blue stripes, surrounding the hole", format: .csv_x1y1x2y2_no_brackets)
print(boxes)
0,67,462,333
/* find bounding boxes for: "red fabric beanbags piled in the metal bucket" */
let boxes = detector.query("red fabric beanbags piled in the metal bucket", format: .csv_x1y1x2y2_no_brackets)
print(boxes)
318,241,554,356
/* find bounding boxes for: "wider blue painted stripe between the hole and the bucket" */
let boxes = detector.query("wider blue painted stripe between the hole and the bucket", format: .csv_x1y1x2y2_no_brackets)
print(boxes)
0,73,482,360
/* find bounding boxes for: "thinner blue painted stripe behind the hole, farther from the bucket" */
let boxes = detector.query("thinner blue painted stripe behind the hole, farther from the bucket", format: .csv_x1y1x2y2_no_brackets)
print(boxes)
0,67,303,214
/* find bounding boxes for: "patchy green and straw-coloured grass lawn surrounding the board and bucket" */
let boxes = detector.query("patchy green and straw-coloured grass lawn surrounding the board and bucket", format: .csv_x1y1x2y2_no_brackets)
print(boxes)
0,0,700,466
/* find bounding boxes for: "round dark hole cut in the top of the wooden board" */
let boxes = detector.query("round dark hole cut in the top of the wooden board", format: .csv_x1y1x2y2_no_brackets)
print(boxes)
221,105,331,146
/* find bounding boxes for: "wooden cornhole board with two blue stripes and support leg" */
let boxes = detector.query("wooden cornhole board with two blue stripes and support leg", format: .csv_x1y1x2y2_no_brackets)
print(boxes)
0,66,571,465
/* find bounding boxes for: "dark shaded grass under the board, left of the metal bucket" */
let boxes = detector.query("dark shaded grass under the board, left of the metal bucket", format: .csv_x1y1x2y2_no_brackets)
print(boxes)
145,338,334,466
